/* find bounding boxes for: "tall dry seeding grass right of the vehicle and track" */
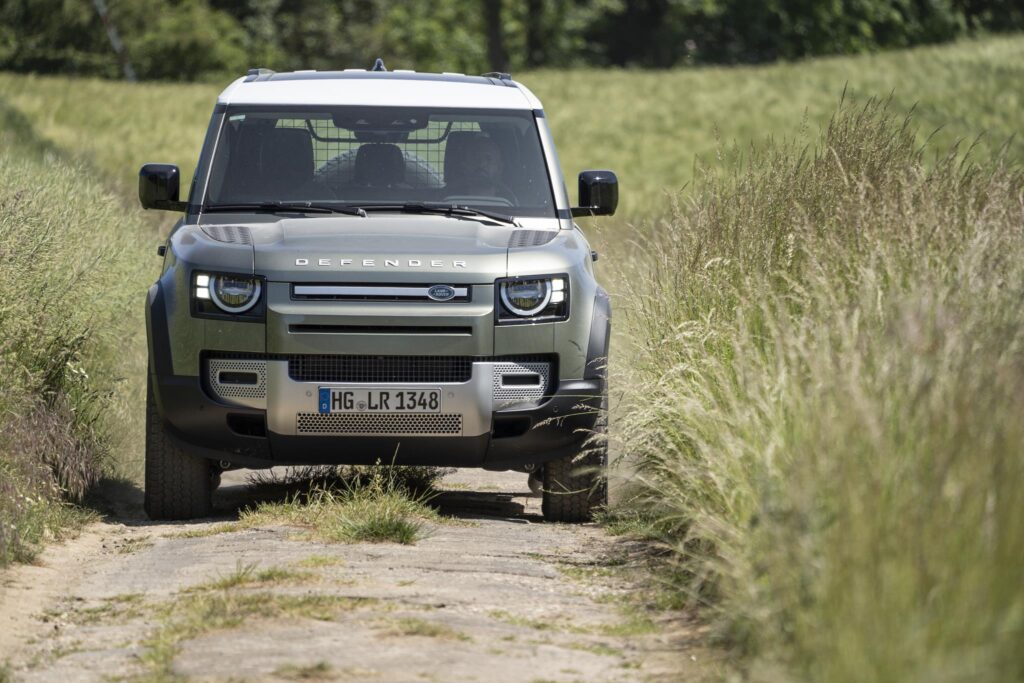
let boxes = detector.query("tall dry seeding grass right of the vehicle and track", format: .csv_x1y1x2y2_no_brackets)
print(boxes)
617,97,1024,682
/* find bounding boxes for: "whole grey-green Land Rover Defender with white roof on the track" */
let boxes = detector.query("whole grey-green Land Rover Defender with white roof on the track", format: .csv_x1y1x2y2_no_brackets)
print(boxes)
139,61,618,522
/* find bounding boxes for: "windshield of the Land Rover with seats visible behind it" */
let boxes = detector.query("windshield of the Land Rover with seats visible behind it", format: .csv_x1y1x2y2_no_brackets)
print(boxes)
204,106,556,217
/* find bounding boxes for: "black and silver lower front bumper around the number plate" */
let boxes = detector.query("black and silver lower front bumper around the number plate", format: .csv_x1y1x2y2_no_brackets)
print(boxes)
153,358,604,469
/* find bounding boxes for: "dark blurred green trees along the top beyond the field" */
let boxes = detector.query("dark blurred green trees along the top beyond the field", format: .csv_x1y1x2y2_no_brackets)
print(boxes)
0,0,1024,81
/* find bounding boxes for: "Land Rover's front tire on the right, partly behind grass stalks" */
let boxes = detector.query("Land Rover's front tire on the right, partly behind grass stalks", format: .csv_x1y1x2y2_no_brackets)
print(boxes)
541,390,608,524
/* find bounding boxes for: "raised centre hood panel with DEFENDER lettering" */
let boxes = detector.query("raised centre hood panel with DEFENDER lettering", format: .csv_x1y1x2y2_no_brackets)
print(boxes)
247,214,515,284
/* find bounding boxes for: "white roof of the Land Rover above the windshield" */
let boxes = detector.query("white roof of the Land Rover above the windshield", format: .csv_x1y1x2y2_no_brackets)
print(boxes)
217,70,542,110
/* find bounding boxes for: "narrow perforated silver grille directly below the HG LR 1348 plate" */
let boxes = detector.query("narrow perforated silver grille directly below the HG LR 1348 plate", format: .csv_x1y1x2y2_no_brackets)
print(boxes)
295,413,462,436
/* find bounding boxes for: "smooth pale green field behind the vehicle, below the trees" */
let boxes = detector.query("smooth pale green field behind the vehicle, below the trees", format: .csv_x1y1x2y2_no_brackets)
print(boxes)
0,37,1024,220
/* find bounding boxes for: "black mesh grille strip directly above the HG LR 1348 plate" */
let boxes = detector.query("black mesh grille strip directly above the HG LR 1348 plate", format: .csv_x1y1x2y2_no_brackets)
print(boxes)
288,355,474,384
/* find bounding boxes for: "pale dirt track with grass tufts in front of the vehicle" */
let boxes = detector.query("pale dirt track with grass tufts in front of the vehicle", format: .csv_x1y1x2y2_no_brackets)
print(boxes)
0,470,702,683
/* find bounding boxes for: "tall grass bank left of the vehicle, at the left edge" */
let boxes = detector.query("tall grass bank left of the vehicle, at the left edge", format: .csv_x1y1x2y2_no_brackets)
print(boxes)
0,102,157,566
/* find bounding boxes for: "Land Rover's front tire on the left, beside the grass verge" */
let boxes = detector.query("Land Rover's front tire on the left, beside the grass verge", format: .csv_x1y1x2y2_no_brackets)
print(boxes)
144,379,213,519
